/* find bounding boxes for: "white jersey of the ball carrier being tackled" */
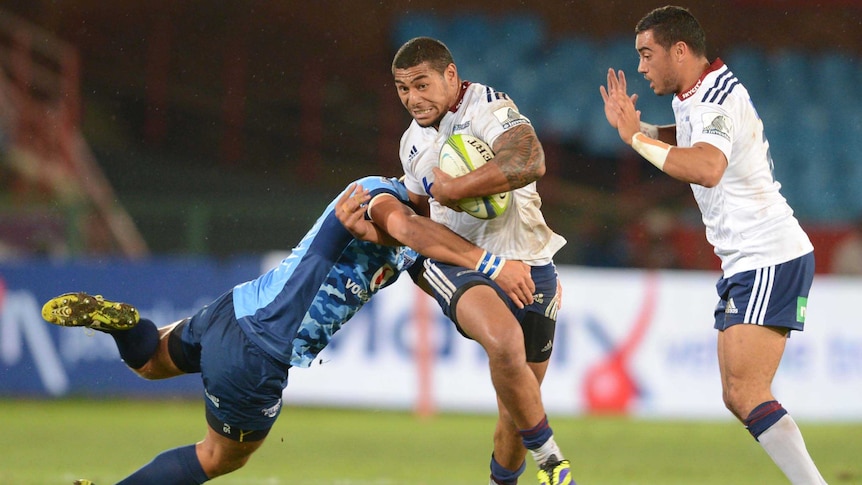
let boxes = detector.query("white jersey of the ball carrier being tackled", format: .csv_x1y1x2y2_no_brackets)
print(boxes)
399,82,566,265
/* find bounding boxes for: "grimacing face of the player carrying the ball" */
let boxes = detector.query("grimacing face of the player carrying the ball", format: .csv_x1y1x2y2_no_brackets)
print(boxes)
395,62,460,127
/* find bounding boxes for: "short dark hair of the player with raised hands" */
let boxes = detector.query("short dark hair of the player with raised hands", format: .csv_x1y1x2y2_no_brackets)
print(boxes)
635,5,706,56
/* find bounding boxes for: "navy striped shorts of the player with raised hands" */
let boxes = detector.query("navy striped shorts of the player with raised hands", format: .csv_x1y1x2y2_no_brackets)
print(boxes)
715,253,814,331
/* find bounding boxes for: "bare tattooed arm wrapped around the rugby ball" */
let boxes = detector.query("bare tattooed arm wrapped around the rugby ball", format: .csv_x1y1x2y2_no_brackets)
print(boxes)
432,125,545,206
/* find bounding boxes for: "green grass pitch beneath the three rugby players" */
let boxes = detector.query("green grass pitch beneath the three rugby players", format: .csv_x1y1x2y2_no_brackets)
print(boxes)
0,400,862,485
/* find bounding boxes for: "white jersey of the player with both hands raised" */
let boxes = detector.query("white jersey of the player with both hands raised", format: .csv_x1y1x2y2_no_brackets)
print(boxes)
673,59,814,277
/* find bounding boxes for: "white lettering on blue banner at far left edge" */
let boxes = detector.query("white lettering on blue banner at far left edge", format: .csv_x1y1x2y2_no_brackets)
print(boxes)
0,291,69,396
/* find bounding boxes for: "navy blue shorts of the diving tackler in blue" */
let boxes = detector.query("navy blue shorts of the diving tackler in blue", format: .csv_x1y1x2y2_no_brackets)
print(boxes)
177,292,289,441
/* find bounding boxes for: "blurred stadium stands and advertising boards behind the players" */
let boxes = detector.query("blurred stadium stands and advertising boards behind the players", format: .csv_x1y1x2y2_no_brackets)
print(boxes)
0,0,862,481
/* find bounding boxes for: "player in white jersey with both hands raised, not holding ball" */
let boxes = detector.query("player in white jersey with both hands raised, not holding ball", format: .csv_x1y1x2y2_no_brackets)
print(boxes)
600,6,826,484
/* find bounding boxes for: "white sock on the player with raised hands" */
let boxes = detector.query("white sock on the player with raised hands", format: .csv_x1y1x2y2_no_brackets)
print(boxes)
757,414,826,485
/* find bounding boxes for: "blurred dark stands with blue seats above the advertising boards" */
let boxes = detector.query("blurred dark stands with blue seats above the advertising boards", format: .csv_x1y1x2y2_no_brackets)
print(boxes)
0,0,862,264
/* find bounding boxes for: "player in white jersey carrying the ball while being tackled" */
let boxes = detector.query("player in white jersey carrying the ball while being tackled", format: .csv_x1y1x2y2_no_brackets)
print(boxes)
392,37,574,485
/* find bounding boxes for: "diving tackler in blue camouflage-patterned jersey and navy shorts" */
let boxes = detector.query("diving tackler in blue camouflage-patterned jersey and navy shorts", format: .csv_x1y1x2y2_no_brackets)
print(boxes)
42,177,535,485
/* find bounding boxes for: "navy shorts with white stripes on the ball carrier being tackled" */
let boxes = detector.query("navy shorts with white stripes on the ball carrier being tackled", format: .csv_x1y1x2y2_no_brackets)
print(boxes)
423,259,560,362
